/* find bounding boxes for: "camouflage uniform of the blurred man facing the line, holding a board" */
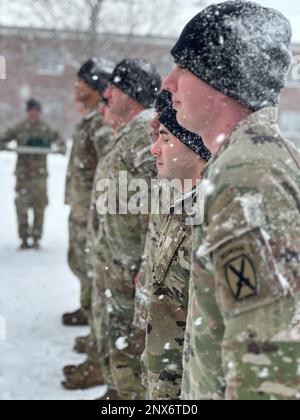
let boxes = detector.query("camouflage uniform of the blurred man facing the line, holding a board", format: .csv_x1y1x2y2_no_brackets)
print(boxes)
0,120,66,240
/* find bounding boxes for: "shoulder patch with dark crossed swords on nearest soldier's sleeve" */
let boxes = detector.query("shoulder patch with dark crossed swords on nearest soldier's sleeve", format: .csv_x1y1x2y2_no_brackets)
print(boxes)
225,255,258,301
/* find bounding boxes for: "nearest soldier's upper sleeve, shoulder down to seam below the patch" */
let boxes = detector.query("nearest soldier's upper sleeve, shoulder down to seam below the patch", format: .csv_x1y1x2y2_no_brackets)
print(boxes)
202,162,300,316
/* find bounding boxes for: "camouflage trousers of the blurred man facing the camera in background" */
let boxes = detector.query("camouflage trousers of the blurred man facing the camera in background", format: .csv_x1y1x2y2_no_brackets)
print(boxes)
15,177,48,240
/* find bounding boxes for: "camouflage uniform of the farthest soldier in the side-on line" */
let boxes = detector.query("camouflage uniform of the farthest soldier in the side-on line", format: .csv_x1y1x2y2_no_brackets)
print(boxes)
65,110,109,319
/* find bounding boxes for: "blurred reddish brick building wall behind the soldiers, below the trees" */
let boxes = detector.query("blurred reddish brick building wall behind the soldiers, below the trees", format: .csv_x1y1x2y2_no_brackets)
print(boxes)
0,28,172,138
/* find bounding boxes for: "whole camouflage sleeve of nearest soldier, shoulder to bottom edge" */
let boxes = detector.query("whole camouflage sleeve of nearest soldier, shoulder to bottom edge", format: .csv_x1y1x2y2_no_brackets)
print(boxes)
197,153,300,400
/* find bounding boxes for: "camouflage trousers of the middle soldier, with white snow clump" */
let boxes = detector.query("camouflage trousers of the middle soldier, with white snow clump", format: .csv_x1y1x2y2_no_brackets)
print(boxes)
101,253,146,400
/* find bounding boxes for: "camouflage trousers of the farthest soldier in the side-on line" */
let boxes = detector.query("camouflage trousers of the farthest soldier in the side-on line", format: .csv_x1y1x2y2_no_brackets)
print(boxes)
68,211,93,324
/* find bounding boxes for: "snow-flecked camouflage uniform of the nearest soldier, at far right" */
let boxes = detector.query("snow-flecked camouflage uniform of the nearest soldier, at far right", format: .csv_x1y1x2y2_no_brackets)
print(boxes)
182,108,300,400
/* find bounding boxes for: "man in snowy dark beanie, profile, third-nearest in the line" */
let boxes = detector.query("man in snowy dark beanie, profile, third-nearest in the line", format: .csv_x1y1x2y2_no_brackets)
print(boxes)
91,59,161,399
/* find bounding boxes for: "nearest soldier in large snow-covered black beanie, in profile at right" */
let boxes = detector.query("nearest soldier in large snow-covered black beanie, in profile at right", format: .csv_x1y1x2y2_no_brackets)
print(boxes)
165,1,300,400
